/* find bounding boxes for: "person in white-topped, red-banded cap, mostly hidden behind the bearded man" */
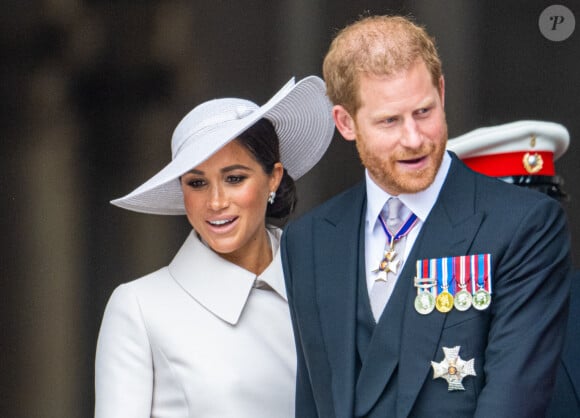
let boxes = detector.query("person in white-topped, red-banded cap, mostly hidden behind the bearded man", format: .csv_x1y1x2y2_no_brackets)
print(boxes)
447,120,580,418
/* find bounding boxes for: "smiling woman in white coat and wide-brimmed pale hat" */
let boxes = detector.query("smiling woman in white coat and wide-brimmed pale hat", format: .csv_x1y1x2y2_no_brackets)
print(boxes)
95,76,334,418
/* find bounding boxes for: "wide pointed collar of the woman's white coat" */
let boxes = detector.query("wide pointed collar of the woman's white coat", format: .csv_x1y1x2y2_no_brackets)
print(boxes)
168,228,287,325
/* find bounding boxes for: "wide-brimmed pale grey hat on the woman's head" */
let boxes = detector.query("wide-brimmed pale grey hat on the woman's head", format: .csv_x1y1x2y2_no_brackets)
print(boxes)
111,76,334,215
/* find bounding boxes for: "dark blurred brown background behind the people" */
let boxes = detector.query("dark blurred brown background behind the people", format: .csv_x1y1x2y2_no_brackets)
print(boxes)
0,0,580,418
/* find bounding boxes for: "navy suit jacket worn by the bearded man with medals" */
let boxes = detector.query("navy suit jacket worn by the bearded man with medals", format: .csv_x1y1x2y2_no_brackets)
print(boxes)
282,153,571,418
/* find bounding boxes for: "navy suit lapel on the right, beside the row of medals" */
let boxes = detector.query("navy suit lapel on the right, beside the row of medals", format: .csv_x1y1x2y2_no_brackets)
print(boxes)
397,158,483,417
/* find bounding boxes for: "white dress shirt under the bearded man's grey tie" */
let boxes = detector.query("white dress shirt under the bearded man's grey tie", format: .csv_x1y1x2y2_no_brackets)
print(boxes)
365,152,451,300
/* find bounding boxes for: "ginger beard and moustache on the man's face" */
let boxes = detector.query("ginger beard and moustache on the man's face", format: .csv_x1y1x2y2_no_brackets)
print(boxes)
356,121,447,195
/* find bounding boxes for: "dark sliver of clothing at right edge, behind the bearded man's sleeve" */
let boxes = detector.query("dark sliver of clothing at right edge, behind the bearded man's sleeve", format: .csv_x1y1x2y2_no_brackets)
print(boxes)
547,271,580,418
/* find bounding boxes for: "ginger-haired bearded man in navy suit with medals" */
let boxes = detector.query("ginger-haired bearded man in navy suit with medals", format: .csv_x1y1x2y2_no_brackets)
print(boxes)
282,16,571,418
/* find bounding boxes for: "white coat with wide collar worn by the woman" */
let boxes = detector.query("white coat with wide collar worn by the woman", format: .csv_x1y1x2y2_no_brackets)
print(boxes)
95,230,296,418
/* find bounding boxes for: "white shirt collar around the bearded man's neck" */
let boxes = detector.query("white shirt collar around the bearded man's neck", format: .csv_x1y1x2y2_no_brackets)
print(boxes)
365,152,451,228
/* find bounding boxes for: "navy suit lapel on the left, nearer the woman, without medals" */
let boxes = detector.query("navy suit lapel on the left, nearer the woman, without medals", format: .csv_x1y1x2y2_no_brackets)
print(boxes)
313,183,365,418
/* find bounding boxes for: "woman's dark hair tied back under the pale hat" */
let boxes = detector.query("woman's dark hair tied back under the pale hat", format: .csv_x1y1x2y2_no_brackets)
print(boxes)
237,118,297,223
